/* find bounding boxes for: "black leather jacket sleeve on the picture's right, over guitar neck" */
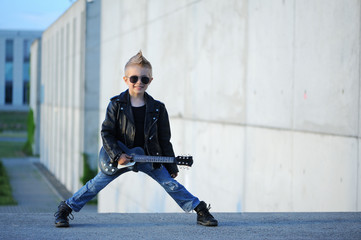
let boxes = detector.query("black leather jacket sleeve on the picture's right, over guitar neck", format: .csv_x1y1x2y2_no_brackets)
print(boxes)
158,104,179,174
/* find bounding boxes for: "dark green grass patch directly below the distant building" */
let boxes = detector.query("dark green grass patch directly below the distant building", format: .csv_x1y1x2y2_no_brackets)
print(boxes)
0,111,28,132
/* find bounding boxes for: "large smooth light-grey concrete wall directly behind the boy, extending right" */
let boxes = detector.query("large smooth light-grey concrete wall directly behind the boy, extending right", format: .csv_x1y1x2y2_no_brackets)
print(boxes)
99,0,361,212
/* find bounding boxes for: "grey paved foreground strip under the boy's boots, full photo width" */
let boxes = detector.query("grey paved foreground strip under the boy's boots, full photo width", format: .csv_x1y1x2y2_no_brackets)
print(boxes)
0,213,361,240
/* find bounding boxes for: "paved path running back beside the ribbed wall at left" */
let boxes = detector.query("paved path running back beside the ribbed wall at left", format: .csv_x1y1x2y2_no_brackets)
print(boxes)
0,158,96,213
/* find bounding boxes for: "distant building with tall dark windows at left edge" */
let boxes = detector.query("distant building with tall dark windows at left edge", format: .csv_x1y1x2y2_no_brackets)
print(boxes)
0,30,42,111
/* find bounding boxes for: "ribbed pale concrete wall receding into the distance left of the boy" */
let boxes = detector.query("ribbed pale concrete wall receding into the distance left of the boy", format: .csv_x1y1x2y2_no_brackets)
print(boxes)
40,0,100,192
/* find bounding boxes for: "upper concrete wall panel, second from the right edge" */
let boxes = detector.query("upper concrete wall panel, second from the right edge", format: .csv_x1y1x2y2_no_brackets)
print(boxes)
247,1,295,129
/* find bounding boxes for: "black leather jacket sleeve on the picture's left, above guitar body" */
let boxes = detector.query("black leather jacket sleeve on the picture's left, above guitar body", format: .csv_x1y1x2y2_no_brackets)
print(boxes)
101,101,122,161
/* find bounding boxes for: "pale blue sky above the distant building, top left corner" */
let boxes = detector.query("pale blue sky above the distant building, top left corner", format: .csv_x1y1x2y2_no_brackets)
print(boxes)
0,0,75,30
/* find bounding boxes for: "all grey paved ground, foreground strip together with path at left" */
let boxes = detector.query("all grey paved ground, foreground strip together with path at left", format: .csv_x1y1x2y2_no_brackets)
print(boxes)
0,158,361,240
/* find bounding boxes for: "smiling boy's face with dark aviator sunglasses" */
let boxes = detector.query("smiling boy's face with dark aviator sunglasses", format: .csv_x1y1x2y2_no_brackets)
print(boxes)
123,65,153,96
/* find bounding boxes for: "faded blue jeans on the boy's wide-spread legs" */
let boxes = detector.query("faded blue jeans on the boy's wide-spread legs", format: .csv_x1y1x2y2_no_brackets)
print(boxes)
66,163,200,212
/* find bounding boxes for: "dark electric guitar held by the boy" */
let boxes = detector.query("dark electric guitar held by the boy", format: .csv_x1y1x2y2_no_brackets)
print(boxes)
98,141,193,176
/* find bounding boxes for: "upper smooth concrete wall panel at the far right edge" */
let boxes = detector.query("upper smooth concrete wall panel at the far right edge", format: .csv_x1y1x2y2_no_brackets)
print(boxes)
294,0,360,136
